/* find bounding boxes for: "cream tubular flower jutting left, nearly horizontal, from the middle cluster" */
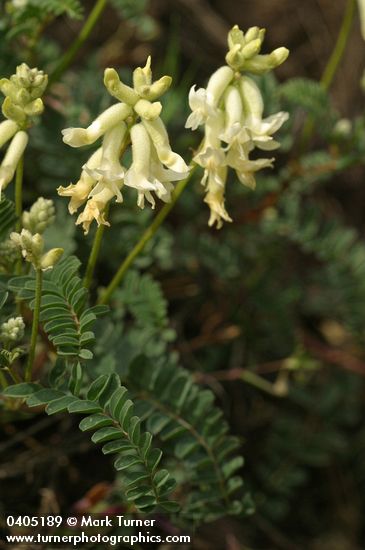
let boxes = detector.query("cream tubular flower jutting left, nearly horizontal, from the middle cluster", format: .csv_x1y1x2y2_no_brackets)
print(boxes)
62,103,132,147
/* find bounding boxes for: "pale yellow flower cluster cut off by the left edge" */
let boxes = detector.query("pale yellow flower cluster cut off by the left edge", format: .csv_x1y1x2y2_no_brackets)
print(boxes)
0,63,48,197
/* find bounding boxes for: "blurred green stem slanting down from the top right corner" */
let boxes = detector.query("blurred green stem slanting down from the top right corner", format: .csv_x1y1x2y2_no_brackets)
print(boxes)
300,0,356,153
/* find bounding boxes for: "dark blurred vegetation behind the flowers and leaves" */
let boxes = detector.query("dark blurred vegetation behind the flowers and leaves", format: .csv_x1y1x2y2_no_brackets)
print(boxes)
0,0,365,550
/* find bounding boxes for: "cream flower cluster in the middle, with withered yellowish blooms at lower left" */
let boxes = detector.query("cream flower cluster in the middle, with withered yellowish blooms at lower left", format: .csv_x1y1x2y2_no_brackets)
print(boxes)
57,57,189,233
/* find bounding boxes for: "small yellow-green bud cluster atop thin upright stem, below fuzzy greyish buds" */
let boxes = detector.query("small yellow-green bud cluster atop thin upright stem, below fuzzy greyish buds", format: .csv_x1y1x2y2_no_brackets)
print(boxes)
10,229,63,271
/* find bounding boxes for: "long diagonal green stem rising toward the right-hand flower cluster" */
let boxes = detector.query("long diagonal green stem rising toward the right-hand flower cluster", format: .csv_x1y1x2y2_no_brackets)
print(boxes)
99,167,194,304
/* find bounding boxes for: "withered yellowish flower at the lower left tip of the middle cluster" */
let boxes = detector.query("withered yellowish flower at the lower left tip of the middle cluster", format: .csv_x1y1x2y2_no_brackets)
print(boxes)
57,147,103,214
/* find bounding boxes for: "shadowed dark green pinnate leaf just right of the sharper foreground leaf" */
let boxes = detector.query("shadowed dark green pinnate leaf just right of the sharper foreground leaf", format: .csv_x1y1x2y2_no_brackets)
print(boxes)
128,357,252,522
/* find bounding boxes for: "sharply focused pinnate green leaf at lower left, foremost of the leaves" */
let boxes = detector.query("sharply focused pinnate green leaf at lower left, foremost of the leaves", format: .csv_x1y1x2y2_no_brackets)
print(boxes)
3,375,179,513
